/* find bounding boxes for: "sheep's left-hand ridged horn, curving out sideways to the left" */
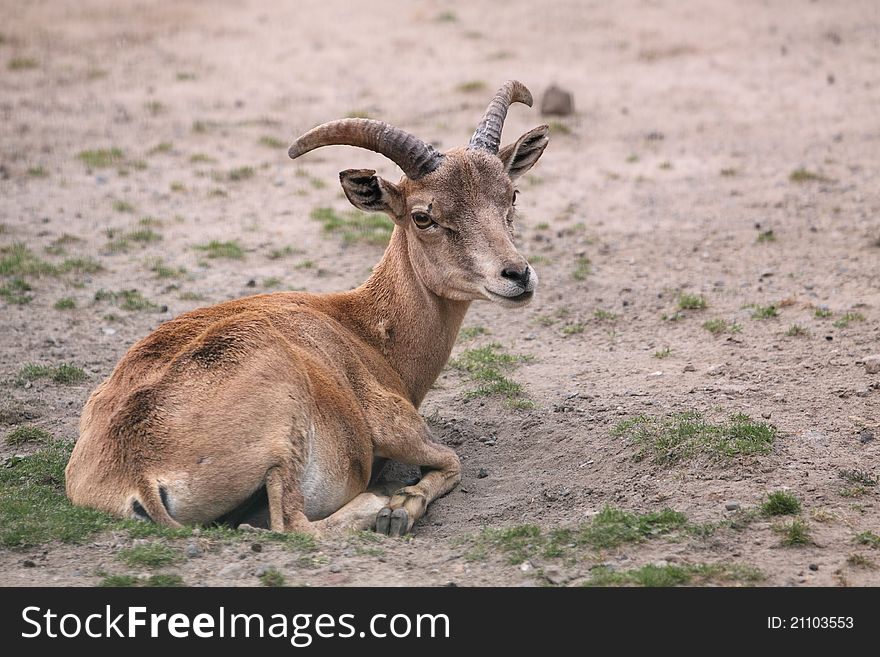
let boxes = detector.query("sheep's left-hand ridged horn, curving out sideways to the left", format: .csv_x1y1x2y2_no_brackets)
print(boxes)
287,119,443,180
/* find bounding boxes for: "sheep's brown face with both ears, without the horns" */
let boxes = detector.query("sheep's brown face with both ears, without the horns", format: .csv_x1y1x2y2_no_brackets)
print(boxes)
340,126,547,306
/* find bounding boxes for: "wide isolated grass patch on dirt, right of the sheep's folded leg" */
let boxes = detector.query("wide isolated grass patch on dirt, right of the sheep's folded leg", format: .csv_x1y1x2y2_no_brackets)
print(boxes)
612,411,776,465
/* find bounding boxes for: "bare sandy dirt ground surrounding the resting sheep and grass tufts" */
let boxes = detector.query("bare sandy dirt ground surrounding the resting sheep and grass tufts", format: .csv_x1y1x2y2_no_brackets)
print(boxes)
0,0,880,586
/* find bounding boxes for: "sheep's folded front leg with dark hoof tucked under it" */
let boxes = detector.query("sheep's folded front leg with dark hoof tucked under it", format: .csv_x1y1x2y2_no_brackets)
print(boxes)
375,406,461,536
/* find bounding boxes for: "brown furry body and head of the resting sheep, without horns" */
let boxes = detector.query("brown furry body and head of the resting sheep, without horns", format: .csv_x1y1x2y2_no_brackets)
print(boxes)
66,111,546,534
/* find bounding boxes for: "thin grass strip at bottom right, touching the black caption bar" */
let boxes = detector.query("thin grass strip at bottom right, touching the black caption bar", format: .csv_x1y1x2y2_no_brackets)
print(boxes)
584,564,766,587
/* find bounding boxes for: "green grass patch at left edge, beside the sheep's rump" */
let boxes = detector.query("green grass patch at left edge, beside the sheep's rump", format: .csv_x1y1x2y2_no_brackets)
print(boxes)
0,441,113,548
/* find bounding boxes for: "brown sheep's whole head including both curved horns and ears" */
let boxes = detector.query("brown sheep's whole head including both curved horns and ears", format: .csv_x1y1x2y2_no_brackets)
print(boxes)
289,81,549,305
